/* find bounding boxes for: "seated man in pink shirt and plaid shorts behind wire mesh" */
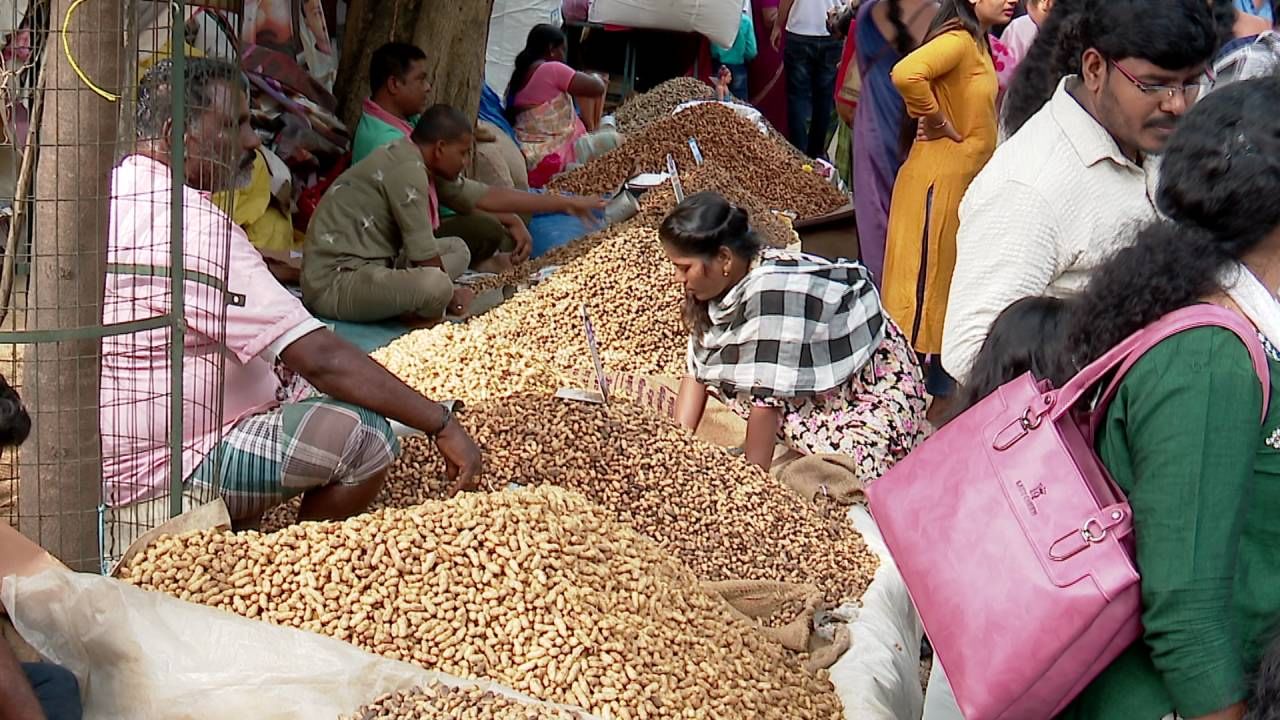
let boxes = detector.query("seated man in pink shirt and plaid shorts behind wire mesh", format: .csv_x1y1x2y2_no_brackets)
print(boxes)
101,58,481,529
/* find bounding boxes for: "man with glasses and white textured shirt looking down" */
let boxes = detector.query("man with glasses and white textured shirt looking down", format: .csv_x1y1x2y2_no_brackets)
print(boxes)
942,0,1217,384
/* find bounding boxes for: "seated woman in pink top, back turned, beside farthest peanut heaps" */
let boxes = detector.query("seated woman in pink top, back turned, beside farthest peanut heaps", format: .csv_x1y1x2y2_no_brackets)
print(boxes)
507,24,622,184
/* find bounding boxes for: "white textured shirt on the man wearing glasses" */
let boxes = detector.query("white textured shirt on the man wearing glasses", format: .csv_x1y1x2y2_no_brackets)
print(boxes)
942,76,1158,383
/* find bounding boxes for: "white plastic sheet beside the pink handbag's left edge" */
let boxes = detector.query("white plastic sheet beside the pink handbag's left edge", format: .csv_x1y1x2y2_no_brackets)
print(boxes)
831,505,924,720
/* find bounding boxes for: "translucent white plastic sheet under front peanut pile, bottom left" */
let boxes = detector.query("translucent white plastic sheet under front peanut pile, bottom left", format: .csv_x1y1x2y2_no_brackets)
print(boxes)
0,569,594,720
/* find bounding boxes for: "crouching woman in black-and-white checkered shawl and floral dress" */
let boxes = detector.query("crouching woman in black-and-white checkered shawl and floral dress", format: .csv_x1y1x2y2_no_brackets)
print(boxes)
659,192,928,483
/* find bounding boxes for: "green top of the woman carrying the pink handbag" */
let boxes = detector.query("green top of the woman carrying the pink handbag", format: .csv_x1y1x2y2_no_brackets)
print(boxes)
1059,328,1280,720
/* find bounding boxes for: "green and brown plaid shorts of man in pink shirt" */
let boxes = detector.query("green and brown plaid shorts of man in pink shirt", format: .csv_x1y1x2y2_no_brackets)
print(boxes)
191,397,399,520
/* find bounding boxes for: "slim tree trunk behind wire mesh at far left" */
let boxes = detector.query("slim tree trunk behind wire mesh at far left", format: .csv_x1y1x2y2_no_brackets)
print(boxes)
18,0,125,570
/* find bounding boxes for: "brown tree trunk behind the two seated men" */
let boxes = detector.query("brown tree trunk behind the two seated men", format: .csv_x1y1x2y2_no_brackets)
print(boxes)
334,0,494,132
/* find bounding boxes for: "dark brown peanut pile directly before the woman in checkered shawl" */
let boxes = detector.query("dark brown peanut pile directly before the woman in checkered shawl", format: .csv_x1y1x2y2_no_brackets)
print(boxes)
368,395,878,603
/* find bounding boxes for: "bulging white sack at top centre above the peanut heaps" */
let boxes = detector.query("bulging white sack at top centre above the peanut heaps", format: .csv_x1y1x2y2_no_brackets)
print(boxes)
590,0,742,47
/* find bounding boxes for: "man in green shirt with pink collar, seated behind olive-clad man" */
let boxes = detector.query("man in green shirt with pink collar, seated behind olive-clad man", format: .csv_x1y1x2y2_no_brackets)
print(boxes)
351,42,532,273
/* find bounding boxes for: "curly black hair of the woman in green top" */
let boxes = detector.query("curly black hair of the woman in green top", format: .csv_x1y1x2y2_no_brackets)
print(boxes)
1068,77,1280,366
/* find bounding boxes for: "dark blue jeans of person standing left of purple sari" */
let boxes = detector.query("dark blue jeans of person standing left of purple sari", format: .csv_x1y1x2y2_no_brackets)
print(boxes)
782,32,844,159
